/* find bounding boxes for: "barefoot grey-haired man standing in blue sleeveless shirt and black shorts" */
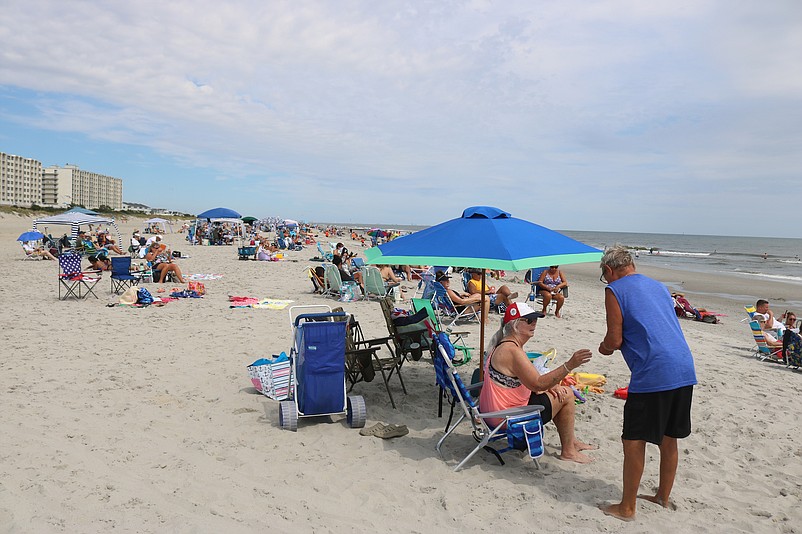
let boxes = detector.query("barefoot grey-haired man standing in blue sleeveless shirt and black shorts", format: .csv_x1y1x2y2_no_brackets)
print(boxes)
599,245,696,521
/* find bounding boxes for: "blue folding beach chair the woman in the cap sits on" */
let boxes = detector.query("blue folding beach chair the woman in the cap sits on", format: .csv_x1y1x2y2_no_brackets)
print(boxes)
434,333,544,471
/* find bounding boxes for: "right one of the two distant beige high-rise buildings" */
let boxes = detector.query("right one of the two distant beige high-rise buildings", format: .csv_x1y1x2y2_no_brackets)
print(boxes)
42,165,123,210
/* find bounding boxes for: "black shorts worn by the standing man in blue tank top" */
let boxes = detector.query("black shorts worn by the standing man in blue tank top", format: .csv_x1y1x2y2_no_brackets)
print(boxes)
621,386,693,445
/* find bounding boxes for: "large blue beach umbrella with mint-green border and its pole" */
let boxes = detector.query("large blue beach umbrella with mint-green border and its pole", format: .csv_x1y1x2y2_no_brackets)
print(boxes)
365,206,602,368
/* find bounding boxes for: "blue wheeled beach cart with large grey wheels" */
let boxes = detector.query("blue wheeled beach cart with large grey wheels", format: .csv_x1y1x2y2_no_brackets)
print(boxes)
279,306,367,431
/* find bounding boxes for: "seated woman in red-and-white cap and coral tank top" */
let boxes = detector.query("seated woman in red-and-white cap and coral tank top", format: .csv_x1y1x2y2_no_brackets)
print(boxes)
479,302,595,464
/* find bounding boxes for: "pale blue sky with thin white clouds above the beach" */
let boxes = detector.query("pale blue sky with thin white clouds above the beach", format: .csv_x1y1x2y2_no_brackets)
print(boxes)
0,0,802,237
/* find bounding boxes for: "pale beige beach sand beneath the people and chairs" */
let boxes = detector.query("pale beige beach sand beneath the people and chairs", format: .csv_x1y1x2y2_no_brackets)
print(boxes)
0,214,802,533
